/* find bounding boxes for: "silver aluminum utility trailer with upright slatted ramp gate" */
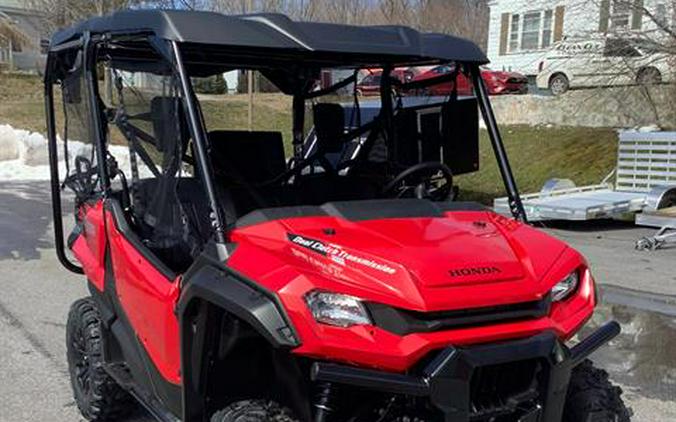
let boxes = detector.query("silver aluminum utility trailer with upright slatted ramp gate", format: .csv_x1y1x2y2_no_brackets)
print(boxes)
493,132,676,221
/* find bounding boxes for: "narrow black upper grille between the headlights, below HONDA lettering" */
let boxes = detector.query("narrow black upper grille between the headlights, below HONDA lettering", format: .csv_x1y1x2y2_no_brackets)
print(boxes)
366,296,551,335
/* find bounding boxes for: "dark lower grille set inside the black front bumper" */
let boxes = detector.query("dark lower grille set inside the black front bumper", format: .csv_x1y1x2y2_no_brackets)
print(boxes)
470,359,542,420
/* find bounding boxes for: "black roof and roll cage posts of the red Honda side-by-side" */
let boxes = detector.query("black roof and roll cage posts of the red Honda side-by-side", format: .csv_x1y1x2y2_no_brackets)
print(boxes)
45,11,526,273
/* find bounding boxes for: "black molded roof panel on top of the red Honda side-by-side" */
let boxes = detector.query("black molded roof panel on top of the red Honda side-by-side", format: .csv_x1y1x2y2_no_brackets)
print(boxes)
51,10,488,64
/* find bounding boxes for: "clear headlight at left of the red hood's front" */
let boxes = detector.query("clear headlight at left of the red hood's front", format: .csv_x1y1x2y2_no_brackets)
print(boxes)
305,290,372,328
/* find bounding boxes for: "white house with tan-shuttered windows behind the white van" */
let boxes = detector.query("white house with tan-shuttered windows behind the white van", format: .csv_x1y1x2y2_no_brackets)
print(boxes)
487,0,676,76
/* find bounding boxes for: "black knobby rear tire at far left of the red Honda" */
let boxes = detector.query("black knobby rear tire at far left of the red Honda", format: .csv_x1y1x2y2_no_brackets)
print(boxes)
66,299,136,422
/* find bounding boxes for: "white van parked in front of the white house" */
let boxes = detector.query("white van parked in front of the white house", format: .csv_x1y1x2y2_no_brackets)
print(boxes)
537,37,674,95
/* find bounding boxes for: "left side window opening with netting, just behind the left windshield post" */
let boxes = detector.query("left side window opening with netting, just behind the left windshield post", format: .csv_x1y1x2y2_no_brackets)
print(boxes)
108,68,201,269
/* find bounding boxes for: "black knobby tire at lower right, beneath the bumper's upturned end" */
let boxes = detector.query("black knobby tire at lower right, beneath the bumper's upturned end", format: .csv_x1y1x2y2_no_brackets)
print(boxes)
563,360,631,422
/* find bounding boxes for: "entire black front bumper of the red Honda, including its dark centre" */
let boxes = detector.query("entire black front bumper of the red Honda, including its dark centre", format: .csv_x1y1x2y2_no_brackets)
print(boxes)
312,321,620,422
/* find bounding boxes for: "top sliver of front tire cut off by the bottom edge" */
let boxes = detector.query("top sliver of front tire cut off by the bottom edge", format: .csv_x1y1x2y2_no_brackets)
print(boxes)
211,400,299,422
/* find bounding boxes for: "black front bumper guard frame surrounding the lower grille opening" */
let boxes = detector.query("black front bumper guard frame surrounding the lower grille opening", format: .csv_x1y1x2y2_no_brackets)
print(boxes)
311,321,620,422
